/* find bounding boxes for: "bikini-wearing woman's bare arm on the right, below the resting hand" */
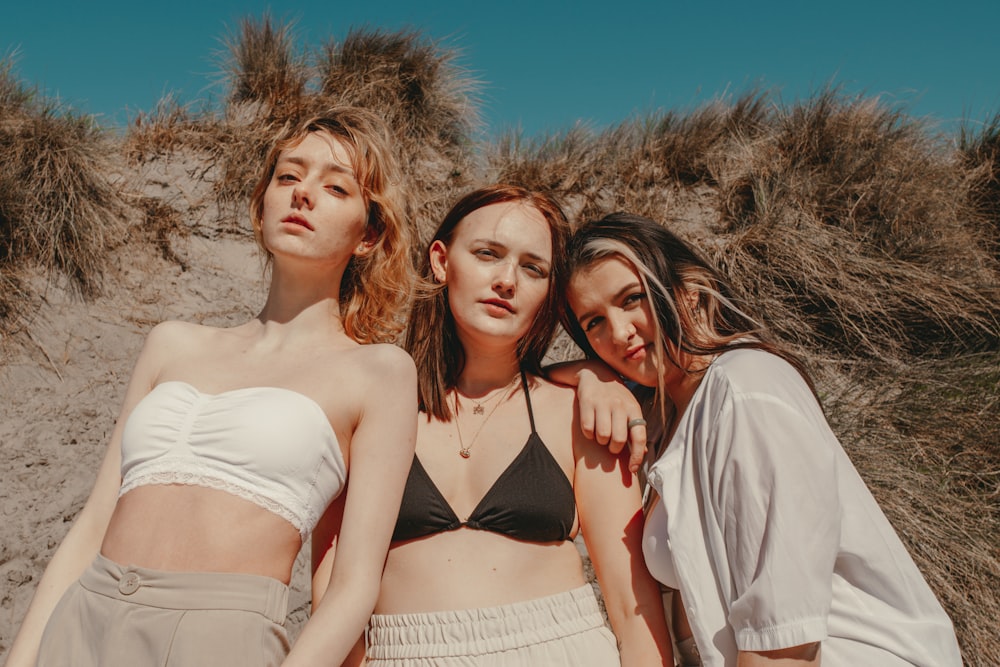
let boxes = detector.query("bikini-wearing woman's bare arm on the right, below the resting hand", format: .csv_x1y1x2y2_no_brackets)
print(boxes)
573,426,674,667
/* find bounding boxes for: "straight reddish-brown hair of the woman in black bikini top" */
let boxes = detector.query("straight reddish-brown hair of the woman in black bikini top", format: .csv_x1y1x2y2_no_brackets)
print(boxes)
404,184,570,420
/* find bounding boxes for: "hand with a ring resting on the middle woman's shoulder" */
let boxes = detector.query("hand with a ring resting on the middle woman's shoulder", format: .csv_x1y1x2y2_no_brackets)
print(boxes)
545,359,646,472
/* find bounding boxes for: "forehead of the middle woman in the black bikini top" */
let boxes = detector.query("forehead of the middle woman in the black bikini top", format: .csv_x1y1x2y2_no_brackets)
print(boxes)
455,202,552,260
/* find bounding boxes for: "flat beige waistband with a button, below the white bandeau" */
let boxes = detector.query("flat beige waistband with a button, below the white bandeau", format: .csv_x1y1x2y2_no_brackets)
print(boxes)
80,554,288,624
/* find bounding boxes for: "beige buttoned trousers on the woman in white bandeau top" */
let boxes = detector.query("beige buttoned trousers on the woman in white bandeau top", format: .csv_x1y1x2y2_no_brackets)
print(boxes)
37,555,289,667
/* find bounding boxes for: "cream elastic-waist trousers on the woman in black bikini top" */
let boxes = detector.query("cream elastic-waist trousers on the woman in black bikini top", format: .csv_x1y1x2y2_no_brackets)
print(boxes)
365,585,621,667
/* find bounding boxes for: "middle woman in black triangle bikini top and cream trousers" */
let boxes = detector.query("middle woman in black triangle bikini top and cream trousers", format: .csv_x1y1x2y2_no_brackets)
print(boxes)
314,185,673,666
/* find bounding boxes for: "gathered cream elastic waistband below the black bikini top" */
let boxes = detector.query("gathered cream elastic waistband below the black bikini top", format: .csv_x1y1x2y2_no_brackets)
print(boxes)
365,584,605,659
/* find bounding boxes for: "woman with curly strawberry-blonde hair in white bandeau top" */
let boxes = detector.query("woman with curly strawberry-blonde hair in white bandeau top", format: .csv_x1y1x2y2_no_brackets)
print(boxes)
7,108,416,667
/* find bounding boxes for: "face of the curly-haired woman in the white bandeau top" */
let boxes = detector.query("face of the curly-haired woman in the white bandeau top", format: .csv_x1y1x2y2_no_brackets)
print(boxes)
261,132,371,266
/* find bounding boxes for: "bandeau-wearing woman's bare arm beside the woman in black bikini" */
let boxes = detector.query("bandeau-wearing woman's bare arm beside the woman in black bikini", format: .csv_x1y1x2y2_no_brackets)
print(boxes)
284,345,417,667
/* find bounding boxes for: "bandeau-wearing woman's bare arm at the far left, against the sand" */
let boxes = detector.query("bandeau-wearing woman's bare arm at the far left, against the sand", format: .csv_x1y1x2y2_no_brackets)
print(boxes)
6,324,169,667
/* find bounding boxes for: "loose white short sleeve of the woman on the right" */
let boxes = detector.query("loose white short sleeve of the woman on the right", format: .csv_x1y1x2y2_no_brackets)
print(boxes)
710,390,841,651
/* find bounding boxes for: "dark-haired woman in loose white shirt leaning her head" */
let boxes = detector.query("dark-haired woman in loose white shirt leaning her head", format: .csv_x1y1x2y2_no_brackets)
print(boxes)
564,213,961,667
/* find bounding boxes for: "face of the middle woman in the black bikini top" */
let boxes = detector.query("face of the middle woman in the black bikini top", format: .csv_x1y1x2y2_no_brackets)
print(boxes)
429,202,552,345
